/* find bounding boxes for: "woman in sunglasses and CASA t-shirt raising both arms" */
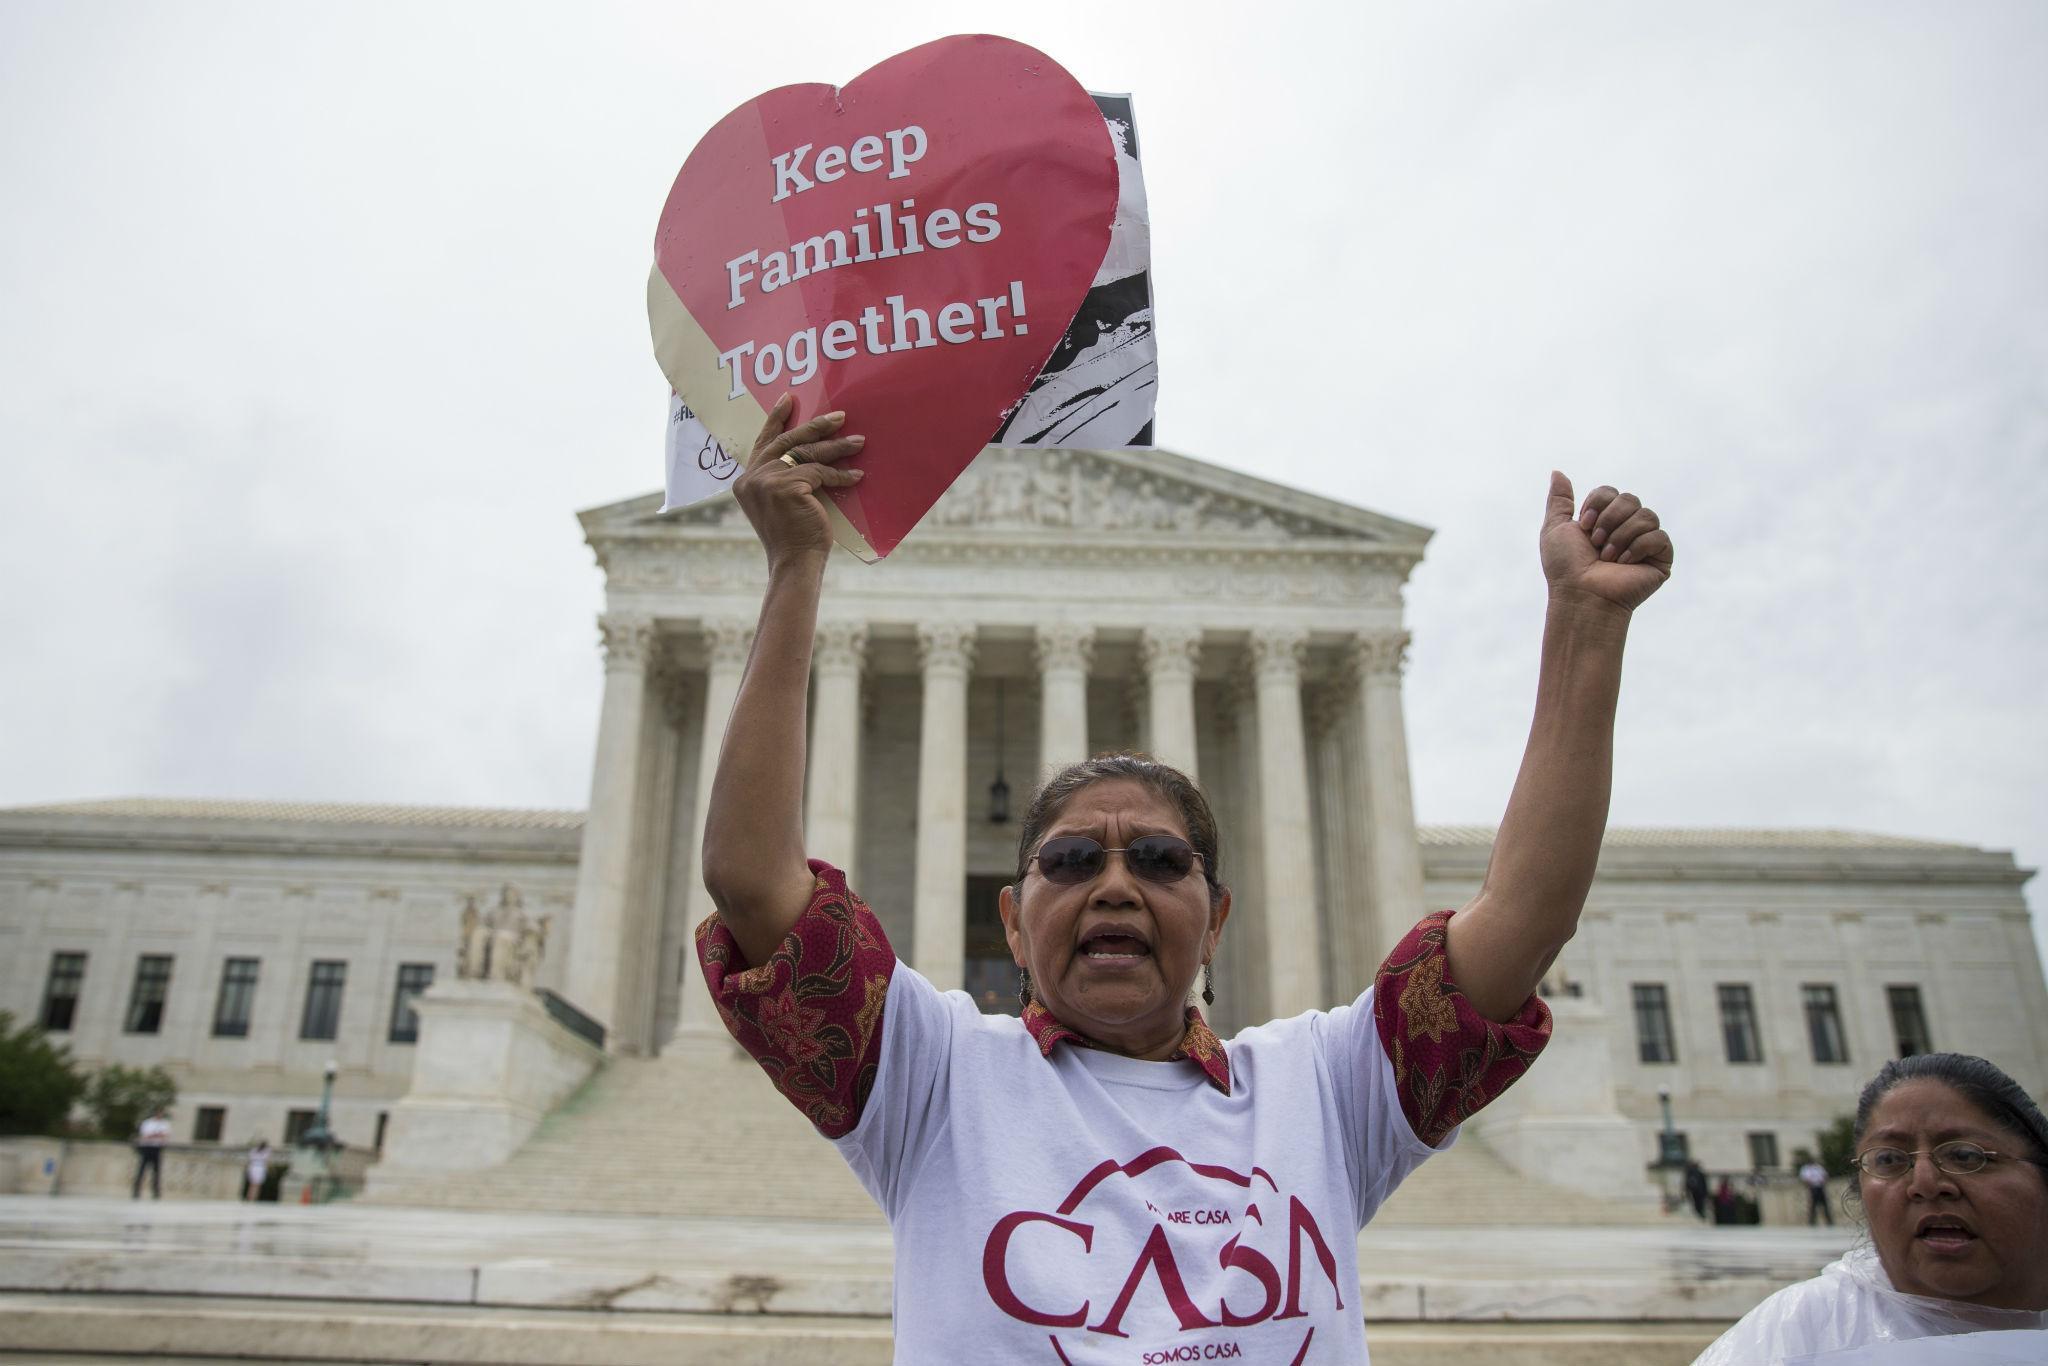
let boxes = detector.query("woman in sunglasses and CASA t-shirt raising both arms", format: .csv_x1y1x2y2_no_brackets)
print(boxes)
696,395,1671,1366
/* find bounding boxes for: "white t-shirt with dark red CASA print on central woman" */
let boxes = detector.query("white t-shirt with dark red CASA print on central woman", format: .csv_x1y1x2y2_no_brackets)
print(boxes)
834,963,1456,1366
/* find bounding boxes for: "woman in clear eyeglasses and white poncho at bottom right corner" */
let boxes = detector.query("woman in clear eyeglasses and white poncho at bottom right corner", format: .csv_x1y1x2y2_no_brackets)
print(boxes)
1694,1053,2048,1366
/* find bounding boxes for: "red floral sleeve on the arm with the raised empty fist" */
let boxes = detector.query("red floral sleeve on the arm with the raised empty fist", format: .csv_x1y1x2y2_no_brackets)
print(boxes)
1372,911,1550,1147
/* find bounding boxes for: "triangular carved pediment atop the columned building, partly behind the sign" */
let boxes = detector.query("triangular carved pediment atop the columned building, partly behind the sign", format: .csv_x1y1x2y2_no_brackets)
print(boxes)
582,446,1430,555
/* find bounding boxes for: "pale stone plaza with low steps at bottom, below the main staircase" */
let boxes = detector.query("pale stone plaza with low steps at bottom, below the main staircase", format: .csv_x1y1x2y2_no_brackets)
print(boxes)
0,1196,1855,1364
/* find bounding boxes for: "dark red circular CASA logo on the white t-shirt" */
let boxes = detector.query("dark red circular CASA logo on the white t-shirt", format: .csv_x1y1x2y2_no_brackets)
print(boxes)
981,1147,1346,1366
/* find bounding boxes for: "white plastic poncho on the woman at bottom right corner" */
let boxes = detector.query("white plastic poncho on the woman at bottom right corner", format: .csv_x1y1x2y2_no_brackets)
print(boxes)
1692,1245,2048,1366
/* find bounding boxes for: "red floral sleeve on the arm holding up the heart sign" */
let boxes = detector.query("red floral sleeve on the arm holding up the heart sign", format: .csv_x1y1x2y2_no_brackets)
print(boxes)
696,858,895,1139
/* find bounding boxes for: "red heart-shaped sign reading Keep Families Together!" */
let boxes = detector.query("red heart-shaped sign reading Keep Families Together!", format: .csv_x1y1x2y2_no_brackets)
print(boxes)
647,35,1116,559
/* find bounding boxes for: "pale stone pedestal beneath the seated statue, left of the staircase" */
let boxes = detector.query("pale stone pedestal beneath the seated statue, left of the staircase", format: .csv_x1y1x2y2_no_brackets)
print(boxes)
371,981,604,1198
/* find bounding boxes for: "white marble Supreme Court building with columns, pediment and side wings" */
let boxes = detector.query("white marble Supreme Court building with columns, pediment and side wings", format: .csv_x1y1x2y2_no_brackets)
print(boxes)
0,449,2048,1169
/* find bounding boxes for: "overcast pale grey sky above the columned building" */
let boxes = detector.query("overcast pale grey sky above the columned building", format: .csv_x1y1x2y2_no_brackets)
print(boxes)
0,0,2048,970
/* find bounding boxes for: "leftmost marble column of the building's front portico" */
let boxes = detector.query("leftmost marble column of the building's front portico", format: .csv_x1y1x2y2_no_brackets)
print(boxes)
563,614,655,1036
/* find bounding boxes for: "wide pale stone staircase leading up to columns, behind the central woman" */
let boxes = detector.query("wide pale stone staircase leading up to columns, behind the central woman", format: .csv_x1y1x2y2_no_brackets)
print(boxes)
372,1044,1659,1227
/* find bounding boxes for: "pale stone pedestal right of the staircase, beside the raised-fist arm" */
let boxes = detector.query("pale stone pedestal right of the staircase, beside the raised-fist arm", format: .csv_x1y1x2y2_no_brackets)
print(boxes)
1466,997,1661,1208
